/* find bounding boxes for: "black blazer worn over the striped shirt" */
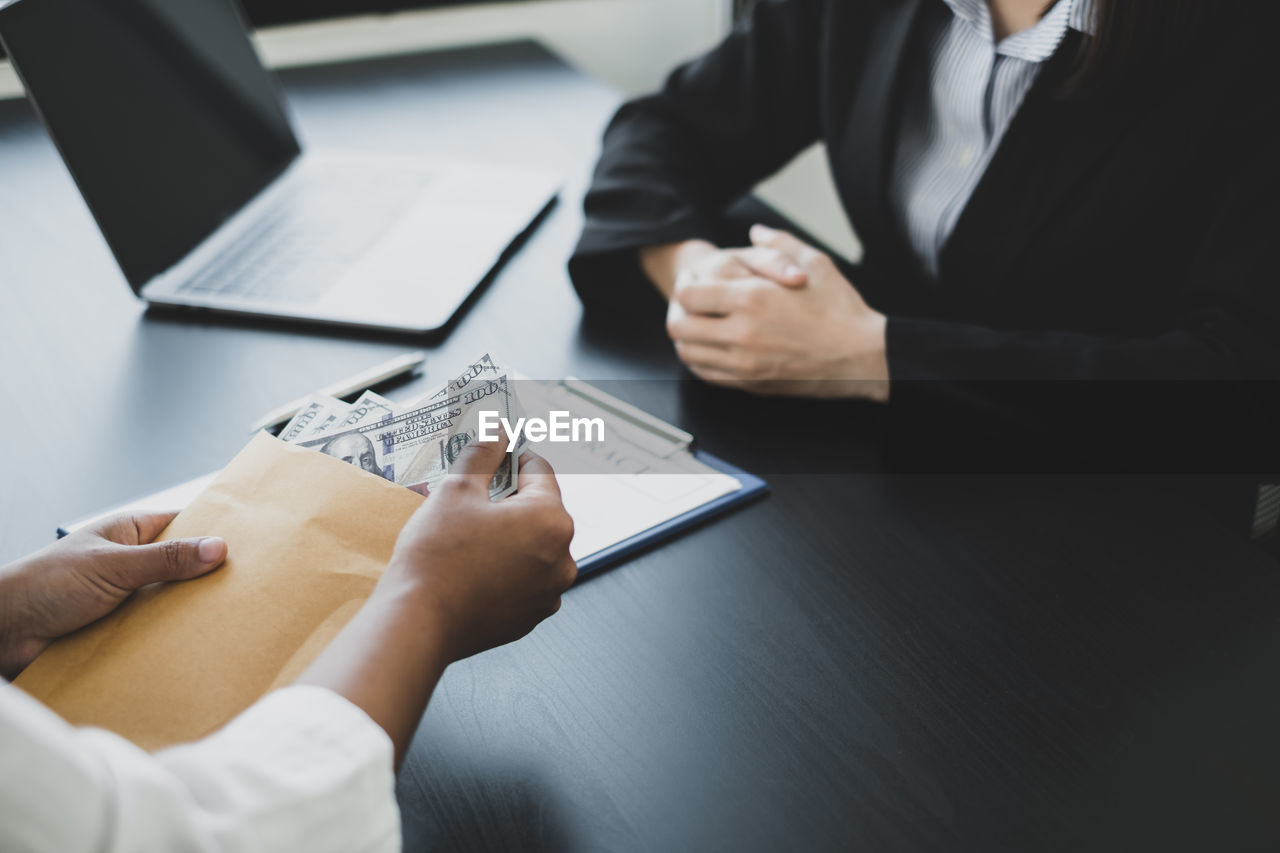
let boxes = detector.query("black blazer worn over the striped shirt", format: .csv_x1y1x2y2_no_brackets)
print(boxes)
570,0,1280,484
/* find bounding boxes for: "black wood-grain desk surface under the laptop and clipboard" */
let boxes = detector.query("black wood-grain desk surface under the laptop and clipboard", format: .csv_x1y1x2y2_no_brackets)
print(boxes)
0,38,1280,850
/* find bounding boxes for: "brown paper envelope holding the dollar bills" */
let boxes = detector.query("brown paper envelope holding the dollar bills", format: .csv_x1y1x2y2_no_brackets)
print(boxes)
14,433,422,749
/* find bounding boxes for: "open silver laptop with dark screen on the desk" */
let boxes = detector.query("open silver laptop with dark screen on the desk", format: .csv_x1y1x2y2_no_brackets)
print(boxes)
0,0,559,332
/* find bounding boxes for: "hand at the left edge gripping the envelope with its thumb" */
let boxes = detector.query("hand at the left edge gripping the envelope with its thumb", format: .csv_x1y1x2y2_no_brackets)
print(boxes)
0,512,227,679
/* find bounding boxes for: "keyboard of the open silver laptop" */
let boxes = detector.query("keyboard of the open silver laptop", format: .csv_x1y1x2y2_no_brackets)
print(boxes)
178,161,430,302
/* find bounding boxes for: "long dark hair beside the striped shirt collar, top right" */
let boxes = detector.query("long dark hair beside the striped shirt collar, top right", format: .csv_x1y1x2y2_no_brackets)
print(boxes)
1064,0,1213,88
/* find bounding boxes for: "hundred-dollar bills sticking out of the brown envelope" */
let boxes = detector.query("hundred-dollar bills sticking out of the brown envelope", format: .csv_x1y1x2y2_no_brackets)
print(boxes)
280,353,524,501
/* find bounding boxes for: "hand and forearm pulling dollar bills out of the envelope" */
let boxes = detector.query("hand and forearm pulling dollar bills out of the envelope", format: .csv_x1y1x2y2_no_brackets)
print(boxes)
300,427,577,762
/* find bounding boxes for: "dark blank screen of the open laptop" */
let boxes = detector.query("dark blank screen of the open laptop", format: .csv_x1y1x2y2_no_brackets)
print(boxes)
0,0,298,291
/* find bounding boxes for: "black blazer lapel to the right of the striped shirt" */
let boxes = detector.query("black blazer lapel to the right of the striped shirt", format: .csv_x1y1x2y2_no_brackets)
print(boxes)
941,32,1132,298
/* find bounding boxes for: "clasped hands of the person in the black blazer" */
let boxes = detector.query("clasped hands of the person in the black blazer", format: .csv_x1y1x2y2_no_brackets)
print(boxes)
641,225,888,402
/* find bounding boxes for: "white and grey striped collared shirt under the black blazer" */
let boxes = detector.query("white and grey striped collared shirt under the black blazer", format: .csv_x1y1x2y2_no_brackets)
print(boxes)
890,0,1094,278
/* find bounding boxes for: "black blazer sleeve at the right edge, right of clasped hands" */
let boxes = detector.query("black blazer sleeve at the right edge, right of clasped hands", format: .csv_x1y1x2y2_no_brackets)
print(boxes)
887,92,1280,474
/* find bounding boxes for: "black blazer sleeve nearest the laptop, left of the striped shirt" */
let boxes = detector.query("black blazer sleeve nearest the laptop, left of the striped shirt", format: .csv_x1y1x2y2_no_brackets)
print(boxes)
570,0,823,314
